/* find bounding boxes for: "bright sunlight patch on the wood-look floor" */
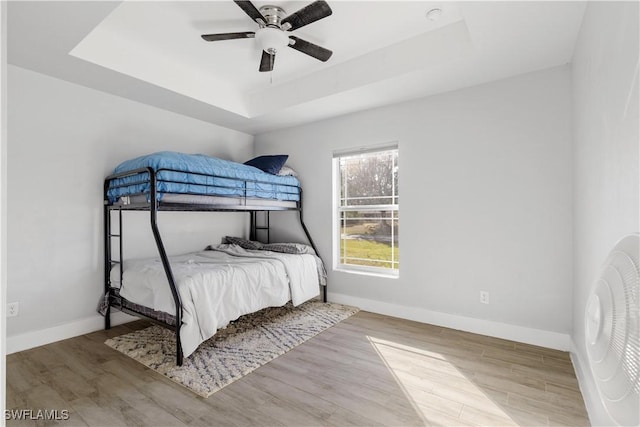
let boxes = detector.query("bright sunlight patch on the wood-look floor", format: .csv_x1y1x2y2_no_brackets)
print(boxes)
367,336,519,426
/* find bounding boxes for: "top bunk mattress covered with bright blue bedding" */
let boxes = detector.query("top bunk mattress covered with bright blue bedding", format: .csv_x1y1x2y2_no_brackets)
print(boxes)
107,151,300,203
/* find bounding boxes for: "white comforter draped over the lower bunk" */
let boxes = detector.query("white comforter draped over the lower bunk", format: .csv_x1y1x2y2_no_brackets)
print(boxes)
112,245,320,357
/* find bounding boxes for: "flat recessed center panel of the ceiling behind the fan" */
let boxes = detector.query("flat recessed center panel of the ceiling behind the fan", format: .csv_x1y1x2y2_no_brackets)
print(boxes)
70,1,462,117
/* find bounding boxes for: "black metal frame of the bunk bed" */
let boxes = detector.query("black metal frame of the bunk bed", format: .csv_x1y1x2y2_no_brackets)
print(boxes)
104,167,327,366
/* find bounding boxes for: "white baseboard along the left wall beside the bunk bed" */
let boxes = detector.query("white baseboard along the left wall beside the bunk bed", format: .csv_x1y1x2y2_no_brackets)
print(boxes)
7,312,137,354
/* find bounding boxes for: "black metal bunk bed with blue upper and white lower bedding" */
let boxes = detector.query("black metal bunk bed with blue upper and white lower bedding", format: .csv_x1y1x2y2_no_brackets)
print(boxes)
103,152,326,365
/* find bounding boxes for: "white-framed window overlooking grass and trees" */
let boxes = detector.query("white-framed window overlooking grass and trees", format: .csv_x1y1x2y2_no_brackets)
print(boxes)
334,146,400,275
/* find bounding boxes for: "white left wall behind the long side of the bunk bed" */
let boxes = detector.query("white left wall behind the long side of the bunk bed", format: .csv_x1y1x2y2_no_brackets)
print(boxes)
7,65,253,352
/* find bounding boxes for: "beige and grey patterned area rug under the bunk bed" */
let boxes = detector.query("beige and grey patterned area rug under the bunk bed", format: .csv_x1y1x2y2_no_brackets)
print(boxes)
105,301,358,397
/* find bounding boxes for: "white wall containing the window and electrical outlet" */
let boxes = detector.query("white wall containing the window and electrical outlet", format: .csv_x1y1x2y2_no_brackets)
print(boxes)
255,66,572,349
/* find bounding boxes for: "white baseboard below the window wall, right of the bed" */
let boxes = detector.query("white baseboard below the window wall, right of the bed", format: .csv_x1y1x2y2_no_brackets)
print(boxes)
327,292,572,351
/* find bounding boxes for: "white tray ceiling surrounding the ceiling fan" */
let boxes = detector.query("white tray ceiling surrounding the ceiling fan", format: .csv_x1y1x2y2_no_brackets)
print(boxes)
7,0,585,133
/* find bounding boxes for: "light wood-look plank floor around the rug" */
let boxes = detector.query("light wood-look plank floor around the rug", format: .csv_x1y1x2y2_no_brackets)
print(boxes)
7,312,589,426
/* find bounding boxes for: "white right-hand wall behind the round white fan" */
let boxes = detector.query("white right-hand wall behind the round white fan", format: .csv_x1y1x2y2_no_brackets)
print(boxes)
572,2,640,425
